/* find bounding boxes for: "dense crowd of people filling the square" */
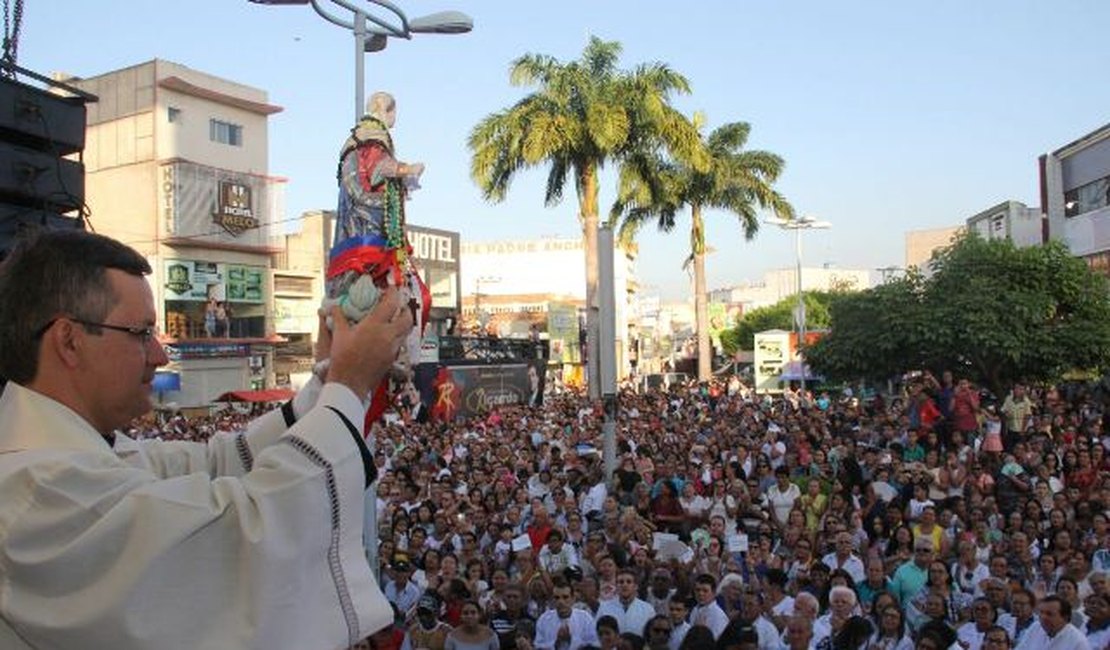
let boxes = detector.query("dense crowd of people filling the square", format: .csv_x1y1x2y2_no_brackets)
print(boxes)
152,373,1110,650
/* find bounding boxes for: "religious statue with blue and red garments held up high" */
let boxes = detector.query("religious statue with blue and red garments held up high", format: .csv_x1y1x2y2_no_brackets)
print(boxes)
324,92,432,423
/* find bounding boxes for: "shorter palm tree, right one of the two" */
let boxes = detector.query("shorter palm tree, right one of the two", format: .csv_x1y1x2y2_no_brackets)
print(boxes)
609,114,794,380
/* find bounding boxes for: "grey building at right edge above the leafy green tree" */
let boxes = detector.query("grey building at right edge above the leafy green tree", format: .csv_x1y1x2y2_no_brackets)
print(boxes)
1040,124,1110,275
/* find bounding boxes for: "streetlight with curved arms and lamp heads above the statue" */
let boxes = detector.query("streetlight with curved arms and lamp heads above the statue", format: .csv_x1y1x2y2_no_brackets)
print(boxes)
250,0,474,121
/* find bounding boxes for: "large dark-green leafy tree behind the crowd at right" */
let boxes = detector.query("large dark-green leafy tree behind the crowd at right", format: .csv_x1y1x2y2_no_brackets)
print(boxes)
808,233,1110,395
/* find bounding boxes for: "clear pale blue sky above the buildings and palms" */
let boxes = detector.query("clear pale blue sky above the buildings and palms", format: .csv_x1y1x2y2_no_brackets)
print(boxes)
19,0,1110,299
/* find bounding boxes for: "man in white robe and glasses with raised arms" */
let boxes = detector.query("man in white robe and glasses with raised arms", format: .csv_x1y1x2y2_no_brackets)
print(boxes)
0,232,412,650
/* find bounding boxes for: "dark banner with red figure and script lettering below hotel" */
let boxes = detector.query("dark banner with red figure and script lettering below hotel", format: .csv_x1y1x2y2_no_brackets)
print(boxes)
417,359,546,422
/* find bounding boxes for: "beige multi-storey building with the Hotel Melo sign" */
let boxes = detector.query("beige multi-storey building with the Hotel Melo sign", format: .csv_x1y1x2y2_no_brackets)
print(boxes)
67,60,285,407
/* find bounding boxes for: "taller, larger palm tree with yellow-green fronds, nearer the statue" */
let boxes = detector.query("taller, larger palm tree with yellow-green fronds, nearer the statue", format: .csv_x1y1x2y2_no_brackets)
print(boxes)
468,37,705,397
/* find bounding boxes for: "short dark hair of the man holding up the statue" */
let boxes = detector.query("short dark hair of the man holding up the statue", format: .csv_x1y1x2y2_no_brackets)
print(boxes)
0,231,151,384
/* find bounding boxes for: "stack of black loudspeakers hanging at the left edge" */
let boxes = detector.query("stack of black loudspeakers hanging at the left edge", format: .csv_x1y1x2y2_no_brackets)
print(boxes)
0,72,97,258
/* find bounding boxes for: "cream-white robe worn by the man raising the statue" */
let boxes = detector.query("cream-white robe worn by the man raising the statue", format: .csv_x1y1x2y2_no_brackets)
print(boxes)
0,379,392,650
